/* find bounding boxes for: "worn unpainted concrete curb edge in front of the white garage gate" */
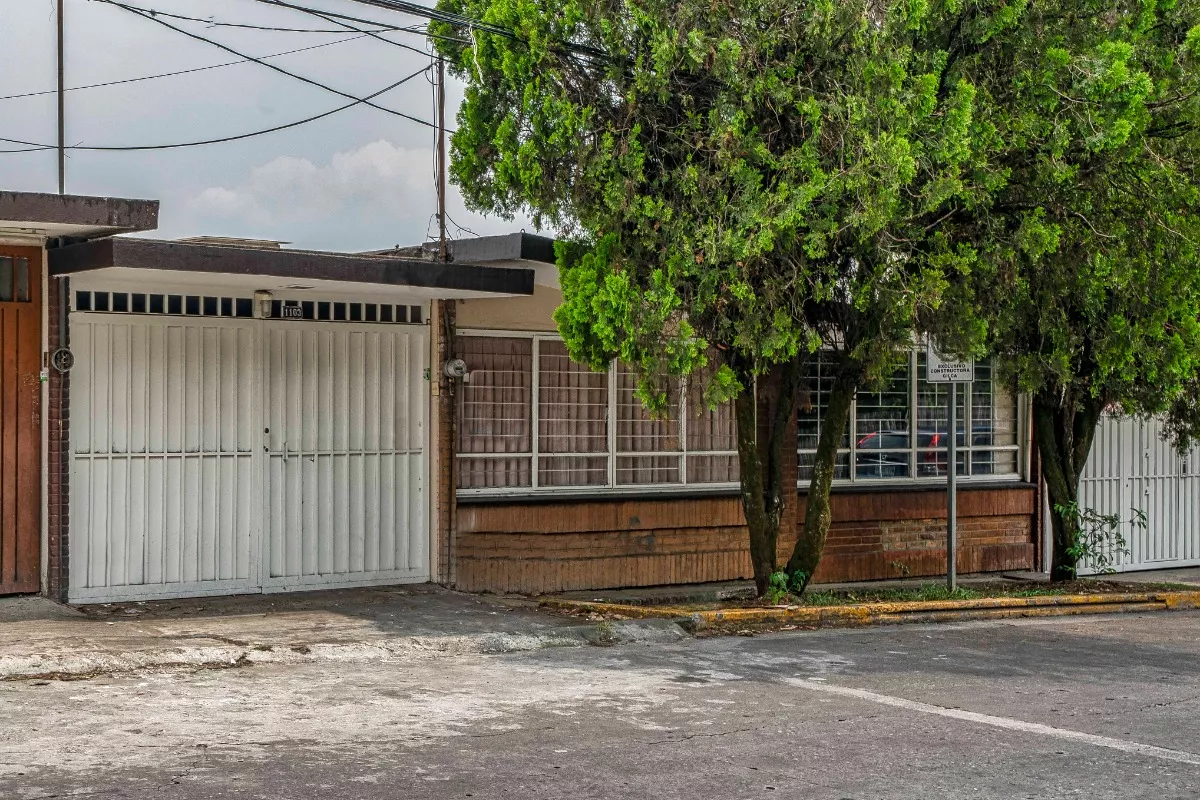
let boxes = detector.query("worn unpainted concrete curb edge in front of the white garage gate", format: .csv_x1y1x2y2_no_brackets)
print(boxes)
0,620,688,682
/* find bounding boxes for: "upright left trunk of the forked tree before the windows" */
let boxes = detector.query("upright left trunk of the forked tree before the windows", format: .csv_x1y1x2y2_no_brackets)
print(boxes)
733,361,800,597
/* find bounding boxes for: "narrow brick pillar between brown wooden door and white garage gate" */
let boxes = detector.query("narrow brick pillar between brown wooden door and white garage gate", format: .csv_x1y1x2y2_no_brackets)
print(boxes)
46,278,71,602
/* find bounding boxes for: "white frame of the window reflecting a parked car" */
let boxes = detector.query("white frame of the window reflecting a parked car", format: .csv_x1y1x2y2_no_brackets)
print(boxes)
797,345,1031,488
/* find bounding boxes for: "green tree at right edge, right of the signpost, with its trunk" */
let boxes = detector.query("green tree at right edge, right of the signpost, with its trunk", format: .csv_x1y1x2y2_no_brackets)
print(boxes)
932,0,1200,579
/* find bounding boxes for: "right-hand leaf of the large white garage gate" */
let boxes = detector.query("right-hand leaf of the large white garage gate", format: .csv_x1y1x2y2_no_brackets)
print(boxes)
265,323,428,589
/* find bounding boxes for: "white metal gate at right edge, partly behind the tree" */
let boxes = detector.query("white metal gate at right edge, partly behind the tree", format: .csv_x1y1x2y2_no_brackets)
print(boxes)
1079,416,1200,573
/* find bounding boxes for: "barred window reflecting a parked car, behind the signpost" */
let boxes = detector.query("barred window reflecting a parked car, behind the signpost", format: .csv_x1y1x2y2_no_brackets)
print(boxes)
797,350,1021,483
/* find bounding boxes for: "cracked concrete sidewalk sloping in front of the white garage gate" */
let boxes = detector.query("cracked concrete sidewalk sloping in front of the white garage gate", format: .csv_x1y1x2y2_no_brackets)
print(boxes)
0,584,686,680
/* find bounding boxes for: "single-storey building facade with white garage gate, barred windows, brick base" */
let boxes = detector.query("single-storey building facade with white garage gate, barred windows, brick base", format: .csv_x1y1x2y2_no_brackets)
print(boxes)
0,193,1056,603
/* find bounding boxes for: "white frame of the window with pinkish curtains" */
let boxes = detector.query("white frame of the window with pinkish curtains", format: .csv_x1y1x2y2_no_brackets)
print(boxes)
454,329,740,497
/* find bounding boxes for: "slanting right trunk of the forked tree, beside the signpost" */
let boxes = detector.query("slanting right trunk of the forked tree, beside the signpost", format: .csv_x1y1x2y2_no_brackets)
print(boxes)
786,374,856,591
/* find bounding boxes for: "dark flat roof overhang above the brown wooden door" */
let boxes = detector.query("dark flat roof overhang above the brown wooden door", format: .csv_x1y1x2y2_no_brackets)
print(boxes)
0,192,158,239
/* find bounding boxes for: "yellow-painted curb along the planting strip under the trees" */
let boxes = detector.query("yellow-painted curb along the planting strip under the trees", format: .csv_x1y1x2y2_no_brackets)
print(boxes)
541,591,1200,631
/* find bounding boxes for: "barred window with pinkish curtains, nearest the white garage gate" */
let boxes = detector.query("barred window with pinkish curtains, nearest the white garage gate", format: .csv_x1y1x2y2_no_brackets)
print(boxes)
456,333,738,493
